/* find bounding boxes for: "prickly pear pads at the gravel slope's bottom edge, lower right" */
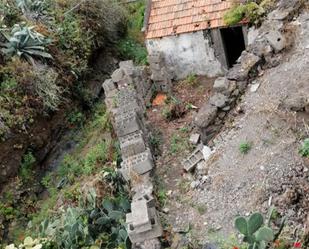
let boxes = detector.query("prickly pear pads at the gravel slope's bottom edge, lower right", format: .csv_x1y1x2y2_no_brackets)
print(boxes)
235,213,275,249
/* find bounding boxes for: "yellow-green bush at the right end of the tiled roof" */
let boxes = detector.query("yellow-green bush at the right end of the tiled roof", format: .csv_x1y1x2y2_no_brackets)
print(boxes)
224,2,265,25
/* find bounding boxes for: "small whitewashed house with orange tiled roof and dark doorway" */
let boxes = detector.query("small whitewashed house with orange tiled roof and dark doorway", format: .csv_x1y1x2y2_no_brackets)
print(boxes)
144,0,247,79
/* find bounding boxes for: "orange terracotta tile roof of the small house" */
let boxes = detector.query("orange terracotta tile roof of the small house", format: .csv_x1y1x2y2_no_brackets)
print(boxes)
146,0,235,39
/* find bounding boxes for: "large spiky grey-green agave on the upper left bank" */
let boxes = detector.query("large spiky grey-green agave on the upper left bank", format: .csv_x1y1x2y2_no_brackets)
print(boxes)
0,23,52,62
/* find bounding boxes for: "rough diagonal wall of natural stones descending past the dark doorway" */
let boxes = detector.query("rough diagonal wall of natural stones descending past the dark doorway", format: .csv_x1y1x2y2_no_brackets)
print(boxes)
194,0,301,144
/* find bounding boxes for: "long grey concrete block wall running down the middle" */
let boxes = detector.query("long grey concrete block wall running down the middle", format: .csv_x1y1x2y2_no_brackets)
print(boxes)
103,59,162,249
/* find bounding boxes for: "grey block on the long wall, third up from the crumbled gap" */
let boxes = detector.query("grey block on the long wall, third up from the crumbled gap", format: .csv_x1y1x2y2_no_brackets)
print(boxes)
115,111,142,137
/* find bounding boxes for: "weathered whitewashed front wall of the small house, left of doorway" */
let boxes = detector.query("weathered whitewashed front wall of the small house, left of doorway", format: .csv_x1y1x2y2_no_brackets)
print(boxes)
146,31,223,79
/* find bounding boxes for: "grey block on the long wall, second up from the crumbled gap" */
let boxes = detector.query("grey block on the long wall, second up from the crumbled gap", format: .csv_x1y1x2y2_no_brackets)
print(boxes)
119,130,146,158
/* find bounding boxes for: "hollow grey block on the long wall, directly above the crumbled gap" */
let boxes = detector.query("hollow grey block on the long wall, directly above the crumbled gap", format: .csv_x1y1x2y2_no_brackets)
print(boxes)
121,150,154,176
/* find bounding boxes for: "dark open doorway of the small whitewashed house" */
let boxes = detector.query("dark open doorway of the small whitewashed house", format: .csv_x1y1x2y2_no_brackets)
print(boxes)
220,27,246,67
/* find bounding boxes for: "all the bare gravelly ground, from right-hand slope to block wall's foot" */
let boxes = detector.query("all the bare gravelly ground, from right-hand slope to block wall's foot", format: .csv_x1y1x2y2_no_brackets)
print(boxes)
149,3,309,248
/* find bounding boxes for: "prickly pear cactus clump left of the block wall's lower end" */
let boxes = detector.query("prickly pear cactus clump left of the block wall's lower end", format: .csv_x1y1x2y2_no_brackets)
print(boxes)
39,193,130,249
